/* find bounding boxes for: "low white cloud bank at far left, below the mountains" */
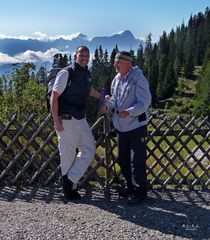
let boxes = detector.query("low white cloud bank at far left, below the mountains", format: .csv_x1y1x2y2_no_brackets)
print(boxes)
0,48,68,64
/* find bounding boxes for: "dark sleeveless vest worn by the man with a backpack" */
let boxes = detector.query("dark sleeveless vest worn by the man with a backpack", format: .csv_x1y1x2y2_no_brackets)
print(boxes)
58,63,91,119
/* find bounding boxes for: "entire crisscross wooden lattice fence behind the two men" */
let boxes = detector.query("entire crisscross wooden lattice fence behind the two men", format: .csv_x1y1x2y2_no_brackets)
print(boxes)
0,115,210,189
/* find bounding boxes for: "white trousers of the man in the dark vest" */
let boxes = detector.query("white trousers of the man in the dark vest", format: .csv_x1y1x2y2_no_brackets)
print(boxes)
57,117,96,183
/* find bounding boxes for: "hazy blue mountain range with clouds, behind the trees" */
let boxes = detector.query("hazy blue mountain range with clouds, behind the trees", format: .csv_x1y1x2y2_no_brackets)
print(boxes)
0,30,145,75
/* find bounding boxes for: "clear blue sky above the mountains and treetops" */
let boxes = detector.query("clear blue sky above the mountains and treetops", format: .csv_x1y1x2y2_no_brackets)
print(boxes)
0,0,210,41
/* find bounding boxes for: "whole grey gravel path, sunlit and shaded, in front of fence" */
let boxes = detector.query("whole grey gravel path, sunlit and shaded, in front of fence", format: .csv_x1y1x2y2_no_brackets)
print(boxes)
0,187,210,240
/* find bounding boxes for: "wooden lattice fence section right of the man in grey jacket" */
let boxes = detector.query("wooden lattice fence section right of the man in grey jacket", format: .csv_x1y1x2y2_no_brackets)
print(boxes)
147,116,210,188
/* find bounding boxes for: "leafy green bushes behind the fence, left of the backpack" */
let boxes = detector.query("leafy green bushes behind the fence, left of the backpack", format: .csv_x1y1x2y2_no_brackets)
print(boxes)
0,63,46,119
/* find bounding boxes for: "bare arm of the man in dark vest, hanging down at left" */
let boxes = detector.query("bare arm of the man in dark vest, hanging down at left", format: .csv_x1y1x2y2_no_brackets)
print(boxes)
50,91,64,132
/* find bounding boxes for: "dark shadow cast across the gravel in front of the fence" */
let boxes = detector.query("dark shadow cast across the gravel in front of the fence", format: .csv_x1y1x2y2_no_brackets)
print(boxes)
0,187,210,239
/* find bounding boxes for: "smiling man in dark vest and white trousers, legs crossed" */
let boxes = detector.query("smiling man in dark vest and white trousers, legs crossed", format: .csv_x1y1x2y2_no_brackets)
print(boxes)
50,46,99,199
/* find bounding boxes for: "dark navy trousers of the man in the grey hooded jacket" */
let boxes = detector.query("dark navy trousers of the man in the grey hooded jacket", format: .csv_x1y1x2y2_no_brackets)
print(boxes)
118,126,147,194
